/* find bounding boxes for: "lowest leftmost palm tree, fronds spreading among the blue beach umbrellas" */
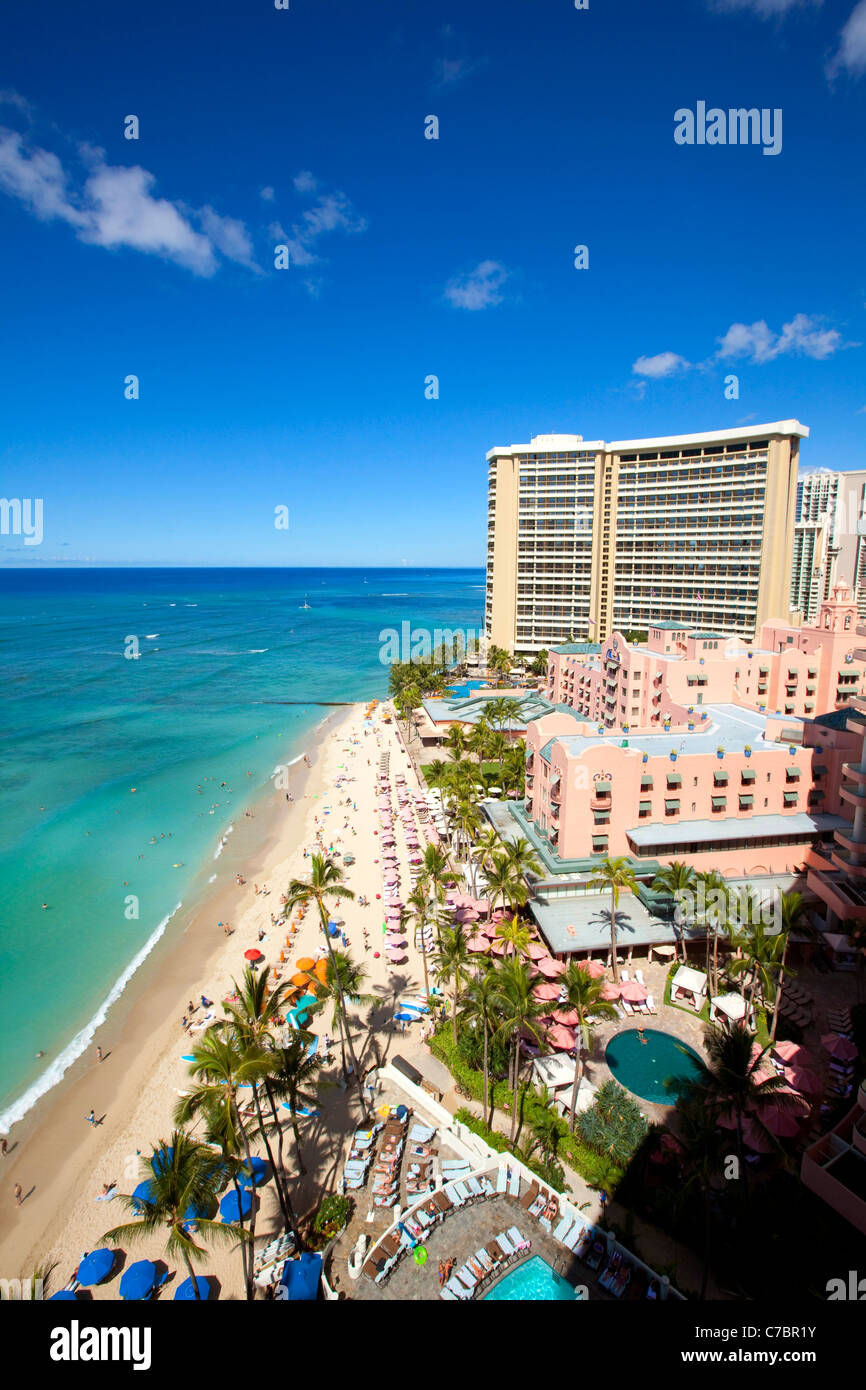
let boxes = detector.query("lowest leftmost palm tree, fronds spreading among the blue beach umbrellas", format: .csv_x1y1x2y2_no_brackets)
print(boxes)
103,1130,250,1298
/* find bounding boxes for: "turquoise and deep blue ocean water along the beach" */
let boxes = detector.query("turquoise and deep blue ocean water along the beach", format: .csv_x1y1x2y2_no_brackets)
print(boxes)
0,569,484,1131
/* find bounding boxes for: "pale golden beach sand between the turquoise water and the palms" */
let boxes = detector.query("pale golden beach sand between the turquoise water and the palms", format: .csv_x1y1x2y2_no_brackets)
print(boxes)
0,705,436,1300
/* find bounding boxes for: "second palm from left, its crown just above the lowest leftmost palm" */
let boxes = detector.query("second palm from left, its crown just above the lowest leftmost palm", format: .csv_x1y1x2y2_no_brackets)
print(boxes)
175,1029,271,1298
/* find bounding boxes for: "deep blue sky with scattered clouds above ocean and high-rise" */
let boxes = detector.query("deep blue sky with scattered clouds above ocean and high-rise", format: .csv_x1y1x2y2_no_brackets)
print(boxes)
0,0,866,566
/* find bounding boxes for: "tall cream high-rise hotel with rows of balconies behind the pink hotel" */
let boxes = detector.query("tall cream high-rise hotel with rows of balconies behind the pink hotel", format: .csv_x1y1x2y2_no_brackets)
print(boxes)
485,420,809,652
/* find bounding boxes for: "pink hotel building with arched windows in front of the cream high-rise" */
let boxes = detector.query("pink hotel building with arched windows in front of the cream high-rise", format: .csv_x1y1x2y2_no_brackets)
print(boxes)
524,584,866,930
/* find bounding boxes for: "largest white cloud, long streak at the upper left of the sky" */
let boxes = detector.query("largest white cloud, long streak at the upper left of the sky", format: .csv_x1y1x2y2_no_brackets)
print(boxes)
0,129,264,275
